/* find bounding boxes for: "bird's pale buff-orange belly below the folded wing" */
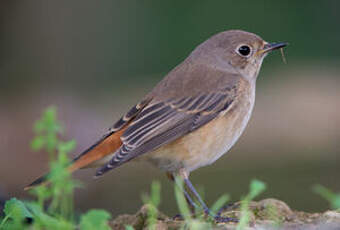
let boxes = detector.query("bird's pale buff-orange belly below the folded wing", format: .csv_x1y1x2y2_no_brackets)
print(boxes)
145,99,252,172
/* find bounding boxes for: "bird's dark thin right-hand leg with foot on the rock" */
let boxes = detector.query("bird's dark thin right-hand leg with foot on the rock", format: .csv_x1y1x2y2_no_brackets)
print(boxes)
180,171,238,222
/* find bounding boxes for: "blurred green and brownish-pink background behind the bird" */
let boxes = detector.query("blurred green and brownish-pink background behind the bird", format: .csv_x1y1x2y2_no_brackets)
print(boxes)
0,0,340,215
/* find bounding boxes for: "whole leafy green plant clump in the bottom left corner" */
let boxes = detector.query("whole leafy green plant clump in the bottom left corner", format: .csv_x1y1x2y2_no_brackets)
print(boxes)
0,107,111,230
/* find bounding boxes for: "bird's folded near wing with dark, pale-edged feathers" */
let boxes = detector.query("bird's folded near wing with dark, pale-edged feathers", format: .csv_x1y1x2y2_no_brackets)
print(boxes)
96,78,238,176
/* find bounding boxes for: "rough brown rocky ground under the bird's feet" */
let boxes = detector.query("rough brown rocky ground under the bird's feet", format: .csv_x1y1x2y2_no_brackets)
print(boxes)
110,199,340,230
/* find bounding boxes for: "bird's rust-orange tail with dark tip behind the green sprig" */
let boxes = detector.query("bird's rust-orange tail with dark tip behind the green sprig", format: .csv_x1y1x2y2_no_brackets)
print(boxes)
24,127,126,190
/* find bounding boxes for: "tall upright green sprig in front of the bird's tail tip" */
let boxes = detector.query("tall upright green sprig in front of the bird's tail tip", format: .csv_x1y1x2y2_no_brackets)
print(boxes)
31,107,77,219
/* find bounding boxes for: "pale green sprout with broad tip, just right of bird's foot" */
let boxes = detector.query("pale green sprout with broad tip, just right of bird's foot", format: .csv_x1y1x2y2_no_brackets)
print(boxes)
236,180,266,230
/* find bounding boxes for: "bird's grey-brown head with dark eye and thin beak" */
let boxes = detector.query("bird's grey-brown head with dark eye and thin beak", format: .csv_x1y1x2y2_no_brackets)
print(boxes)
193,30,287,80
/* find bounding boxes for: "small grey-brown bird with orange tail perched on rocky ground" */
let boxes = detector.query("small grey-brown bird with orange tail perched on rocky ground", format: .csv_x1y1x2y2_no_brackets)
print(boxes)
27,30,287,220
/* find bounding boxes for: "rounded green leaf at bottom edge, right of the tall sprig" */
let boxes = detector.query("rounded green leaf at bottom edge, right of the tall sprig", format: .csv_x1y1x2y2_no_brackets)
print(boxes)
80,209,111,230
